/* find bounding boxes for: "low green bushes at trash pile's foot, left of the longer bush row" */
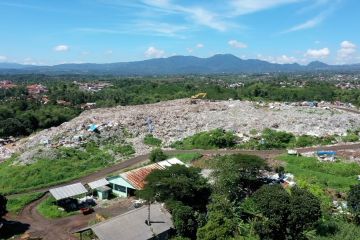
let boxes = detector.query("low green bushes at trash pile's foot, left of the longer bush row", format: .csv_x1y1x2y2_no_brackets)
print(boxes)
171,129,236,150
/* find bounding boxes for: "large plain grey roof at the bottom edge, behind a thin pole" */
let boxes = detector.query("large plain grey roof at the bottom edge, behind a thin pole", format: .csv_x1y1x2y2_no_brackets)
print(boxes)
91,204,173,240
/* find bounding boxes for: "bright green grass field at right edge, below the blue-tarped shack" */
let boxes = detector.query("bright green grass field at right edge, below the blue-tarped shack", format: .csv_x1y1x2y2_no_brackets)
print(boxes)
280,156,360,192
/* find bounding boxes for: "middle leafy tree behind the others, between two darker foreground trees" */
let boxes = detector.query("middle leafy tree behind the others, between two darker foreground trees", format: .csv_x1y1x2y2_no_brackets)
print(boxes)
214,154,267,202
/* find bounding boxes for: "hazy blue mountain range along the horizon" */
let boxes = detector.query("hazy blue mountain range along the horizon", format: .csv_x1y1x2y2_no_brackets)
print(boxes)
0,54,360,75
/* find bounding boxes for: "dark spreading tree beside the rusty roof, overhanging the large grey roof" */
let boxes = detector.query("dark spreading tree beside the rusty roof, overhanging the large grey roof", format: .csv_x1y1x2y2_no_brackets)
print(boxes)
137,165,210,239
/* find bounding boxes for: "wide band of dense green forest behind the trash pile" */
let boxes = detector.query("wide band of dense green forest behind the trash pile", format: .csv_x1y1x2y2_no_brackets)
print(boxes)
0,75,360,137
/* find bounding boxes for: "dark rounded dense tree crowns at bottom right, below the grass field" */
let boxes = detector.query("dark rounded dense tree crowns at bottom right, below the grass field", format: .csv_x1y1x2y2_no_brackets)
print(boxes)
253,185,321,240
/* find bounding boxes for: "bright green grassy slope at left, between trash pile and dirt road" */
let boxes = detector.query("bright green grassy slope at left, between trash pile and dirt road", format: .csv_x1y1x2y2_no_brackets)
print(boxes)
0,145,114,194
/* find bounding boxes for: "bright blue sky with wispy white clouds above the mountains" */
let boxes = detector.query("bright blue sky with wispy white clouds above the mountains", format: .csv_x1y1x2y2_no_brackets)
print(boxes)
0,0,360,65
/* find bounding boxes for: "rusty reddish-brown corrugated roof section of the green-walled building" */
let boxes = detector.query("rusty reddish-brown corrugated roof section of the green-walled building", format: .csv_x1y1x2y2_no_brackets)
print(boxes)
120,163,164,189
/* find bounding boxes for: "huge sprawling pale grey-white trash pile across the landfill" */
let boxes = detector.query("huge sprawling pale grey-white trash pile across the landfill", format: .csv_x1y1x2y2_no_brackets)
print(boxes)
0,99,360,164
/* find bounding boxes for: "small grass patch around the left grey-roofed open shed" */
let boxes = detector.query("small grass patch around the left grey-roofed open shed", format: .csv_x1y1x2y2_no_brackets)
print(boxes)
36,197,79,218
